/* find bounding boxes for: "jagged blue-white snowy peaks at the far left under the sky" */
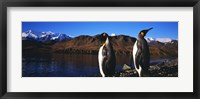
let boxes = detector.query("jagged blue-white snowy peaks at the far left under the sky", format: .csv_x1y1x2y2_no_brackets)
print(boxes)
22,30,72,42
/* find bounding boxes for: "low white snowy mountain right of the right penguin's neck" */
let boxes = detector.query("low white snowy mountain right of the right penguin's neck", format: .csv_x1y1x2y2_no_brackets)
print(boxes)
145,37,177,43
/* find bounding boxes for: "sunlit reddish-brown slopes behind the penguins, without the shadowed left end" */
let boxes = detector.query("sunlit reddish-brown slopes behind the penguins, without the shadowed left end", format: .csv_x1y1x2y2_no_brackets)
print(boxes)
52,35,178,59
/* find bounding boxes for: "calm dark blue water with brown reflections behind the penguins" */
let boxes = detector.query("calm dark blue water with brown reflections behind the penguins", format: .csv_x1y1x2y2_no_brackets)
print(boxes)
22,54,130,77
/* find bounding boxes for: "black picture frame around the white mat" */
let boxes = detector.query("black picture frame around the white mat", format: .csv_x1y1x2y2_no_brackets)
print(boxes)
0,0,200,99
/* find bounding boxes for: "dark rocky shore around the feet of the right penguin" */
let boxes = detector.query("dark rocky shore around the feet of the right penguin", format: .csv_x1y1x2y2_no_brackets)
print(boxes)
115,58,178,77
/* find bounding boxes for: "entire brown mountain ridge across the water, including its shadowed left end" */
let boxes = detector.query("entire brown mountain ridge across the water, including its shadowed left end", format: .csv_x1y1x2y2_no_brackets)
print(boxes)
22,31,178,59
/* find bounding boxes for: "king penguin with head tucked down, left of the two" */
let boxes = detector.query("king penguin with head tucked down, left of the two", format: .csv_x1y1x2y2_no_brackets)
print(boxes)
98,32,116,77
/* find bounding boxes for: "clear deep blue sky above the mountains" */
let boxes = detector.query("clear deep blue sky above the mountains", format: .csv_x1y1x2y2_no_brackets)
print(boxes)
22,22,178,39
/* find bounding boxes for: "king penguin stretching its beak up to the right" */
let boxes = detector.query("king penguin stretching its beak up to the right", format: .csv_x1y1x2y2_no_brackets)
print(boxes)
133,28,153,77
